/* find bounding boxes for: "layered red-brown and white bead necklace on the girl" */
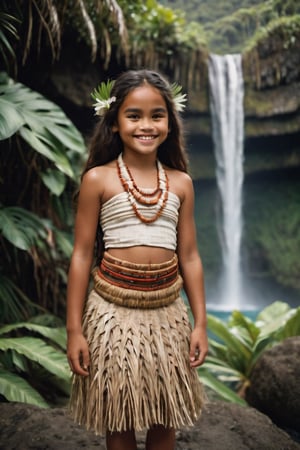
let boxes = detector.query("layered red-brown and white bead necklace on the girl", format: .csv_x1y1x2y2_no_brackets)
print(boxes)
117,153,169,223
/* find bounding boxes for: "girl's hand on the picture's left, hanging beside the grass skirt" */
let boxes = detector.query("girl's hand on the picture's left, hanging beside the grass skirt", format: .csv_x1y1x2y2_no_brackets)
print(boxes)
67,332,90,377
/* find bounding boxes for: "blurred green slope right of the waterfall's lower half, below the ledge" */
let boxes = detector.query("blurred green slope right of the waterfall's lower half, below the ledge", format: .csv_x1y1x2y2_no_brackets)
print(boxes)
244,175,300,291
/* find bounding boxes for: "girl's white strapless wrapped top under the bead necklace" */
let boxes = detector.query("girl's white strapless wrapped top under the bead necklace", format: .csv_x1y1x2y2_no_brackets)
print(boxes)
100,192,180,251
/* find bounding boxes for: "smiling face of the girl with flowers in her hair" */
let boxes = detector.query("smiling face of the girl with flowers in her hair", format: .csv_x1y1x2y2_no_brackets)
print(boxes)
113,84,169,155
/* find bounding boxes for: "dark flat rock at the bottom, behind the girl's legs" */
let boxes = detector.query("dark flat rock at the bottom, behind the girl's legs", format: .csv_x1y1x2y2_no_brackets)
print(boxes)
0,402,300,450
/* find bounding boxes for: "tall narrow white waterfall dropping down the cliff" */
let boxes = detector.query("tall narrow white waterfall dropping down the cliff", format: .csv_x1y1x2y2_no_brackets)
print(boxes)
209,55,244,309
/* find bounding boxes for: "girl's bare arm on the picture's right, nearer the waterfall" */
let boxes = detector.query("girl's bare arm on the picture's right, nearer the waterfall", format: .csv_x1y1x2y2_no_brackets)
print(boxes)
177,174,208,367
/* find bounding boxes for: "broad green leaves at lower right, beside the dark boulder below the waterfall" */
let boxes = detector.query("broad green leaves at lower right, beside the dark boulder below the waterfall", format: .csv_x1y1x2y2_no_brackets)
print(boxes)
198,302,300,404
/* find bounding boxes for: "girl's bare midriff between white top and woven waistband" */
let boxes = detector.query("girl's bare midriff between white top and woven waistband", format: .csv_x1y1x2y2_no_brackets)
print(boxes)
107,245,174,264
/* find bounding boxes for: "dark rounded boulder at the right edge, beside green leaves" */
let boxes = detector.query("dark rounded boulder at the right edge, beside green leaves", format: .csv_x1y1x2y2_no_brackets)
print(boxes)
247,336,300,431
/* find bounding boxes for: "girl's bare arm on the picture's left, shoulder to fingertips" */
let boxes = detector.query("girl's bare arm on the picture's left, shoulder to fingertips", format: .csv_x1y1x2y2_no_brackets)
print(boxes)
66,168,101,376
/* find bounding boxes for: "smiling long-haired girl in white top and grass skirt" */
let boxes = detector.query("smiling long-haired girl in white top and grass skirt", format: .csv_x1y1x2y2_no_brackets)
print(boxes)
67,70,208,450
